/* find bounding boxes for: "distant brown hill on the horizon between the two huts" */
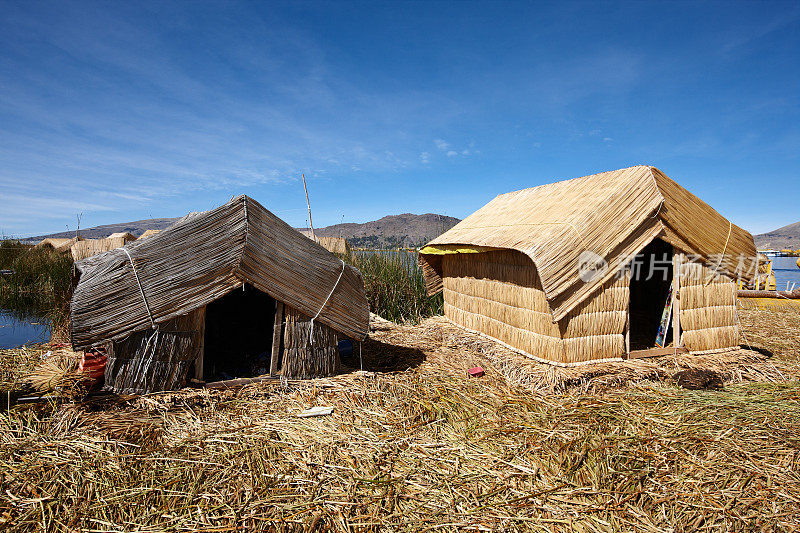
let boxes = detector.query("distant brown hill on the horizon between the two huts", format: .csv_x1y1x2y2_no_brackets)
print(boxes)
298,213,460,248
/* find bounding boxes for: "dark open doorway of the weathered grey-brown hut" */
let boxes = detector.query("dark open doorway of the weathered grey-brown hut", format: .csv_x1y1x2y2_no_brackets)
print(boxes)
202,284,275,381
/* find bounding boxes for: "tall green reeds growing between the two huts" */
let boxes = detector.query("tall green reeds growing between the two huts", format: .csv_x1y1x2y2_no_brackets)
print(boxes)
342,250,444,324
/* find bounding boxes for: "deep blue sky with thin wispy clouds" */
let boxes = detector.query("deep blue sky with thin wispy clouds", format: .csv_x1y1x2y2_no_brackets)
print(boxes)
0,0,800,236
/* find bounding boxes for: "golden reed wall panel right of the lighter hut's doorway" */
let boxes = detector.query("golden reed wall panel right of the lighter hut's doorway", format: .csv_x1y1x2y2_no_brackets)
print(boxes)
680,263,739,352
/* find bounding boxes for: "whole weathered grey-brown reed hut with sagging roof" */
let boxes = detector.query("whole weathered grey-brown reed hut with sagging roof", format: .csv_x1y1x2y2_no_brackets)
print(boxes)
71,196,369,393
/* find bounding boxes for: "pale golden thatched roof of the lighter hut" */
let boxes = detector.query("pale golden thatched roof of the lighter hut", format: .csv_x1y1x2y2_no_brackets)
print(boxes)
420,166,756,320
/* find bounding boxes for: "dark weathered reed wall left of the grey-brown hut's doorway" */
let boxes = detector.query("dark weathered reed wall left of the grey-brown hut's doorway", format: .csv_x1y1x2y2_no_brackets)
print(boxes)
105,307,205,394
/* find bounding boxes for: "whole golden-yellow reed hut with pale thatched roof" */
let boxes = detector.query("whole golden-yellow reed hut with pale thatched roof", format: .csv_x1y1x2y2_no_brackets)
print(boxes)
419,166,756,364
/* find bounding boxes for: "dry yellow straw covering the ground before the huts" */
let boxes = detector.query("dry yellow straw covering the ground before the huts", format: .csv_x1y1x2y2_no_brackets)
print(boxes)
0,311,800,531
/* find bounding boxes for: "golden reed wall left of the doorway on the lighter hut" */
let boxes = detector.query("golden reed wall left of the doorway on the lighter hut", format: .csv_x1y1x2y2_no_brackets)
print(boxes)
442,250,628,363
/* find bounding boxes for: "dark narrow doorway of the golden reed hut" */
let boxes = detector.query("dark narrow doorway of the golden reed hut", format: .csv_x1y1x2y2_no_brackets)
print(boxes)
630,239,672,350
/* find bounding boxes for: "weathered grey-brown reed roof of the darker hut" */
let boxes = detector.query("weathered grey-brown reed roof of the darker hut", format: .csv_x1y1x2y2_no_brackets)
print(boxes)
71,196,369,349
